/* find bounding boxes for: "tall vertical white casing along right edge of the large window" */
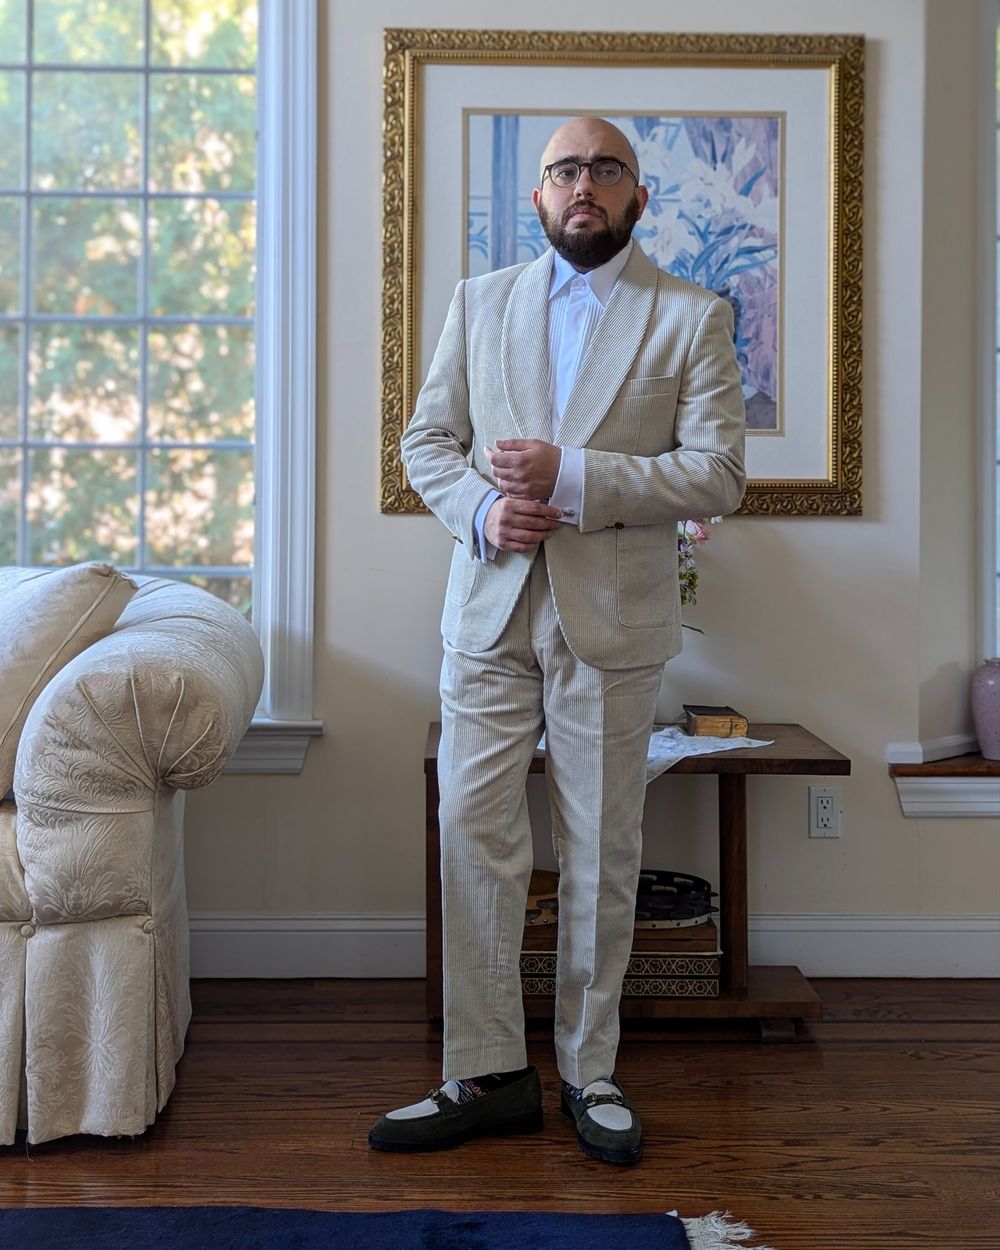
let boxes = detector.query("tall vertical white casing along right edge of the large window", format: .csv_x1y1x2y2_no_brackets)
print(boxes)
254,0,318,721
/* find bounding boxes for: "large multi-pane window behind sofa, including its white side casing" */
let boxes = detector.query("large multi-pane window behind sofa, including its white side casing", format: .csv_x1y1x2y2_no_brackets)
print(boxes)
0,0,318,765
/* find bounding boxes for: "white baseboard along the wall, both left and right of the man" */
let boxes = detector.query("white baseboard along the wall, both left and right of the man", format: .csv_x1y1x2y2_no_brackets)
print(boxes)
191,915,1000,978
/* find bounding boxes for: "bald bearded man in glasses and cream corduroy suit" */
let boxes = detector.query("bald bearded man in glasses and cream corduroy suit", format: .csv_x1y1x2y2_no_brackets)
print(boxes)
369,118,745,1164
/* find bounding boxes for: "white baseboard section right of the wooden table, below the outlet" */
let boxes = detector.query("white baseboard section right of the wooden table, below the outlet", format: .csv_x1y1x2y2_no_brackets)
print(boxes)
749,915,1000,976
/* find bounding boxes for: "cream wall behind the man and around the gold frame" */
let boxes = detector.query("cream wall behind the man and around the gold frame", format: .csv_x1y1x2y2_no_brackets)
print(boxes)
181,0,1000,975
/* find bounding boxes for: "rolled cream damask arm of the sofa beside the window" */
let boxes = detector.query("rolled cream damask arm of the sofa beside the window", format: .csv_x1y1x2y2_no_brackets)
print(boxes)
14,579,264,921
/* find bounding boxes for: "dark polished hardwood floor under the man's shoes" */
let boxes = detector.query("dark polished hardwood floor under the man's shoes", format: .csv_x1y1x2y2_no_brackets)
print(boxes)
0,980,1000,1250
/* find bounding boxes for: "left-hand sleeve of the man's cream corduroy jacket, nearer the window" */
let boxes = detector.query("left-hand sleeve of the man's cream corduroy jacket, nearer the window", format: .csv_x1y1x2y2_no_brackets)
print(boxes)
401,281,494,558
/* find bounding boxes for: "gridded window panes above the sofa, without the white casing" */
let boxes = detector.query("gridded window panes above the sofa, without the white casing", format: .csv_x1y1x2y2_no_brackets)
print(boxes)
0,0,258,615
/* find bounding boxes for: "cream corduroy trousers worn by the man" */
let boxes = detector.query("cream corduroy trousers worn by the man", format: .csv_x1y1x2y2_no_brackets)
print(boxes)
438,549,663,1086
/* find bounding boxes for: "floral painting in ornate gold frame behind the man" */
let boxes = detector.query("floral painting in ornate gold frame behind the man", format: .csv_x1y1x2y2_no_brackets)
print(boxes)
381,30,864,516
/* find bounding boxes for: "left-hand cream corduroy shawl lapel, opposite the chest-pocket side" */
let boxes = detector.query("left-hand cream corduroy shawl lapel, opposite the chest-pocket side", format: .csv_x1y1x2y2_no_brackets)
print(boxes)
500,248,553,443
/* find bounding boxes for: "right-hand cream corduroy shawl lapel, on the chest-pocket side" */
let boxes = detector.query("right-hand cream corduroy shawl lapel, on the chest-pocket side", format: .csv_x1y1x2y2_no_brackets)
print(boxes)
557,243,659,448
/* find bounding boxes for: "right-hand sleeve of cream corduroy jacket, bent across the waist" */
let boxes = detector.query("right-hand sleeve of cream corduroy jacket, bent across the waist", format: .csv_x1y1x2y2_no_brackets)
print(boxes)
580,299,746,533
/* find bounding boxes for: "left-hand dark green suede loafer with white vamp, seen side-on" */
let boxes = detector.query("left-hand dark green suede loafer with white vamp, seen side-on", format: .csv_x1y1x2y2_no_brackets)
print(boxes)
368,1068,541,1151
